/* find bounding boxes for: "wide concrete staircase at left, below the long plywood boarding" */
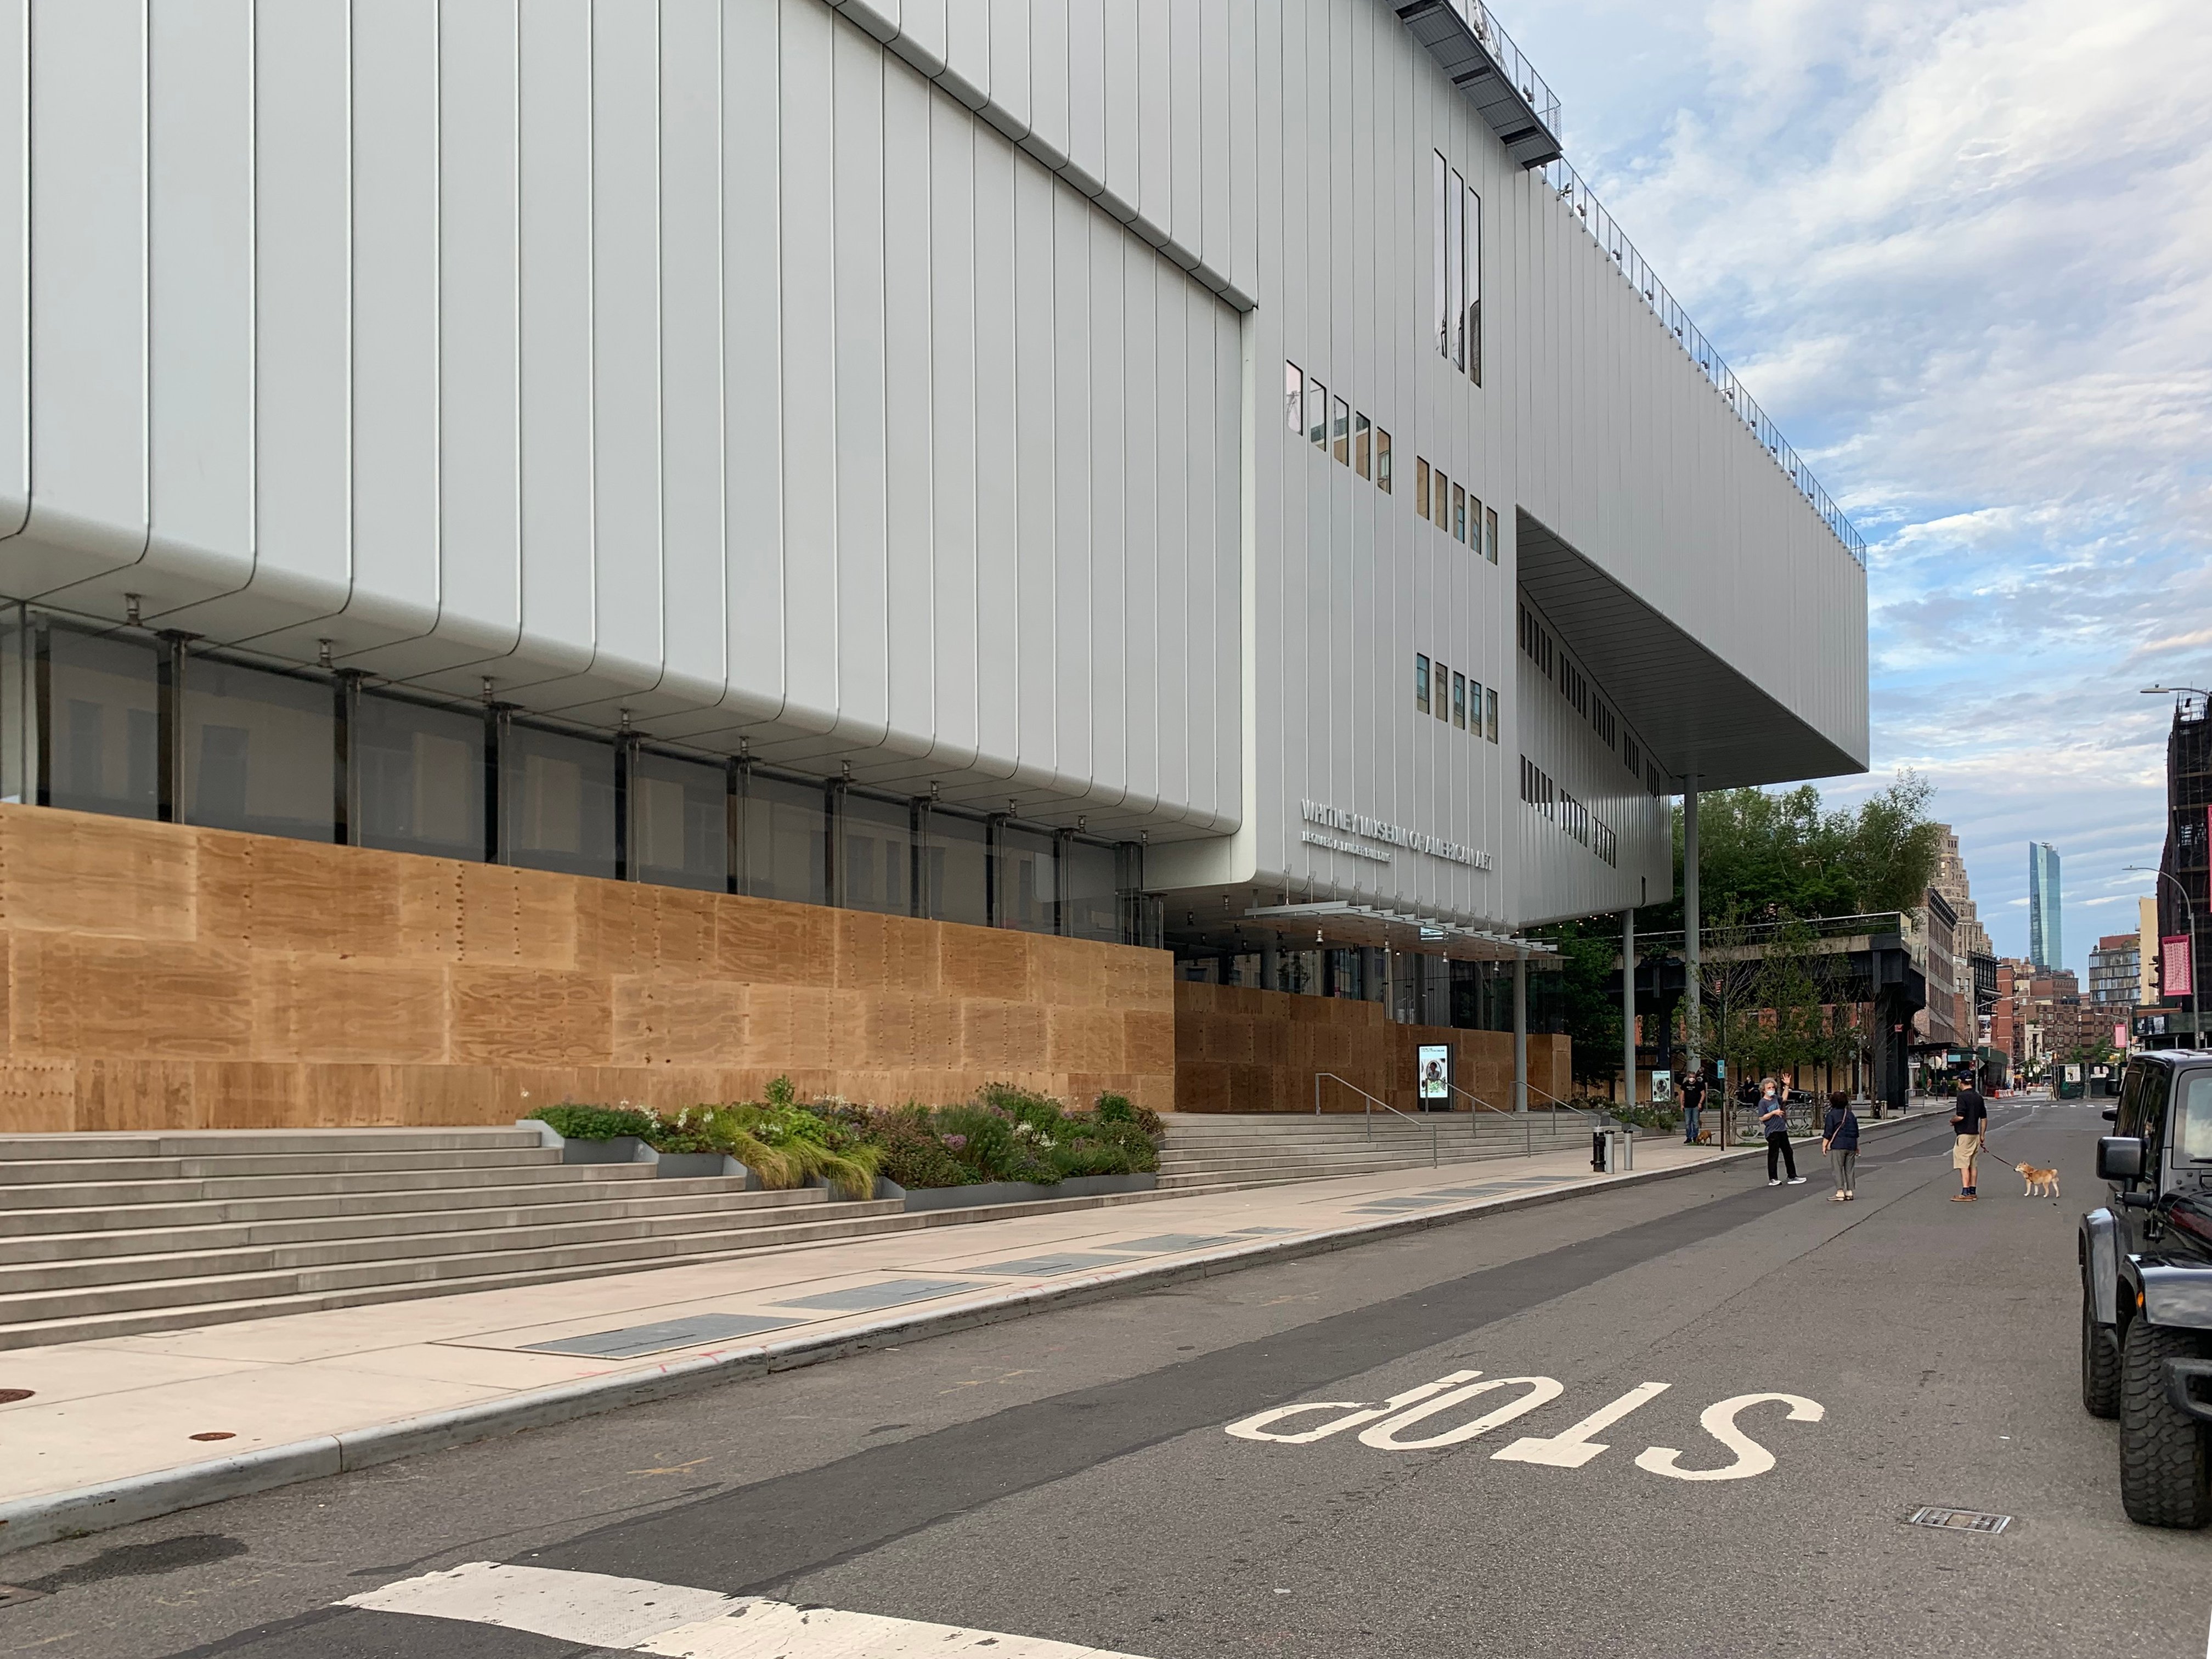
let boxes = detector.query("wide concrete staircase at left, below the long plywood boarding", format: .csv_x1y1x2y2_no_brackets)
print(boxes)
0,1128,900,1350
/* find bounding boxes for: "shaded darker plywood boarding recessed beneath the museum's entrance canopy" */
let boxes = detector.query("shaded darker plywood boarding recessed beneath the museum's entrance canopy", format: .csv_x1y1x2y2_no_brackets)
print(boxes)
1175,980,1568,1113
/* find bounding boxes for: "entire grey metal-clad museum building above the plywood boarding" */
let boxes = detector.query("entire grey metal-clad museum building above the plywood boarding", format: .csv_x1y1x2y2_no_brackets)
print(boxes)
0,0,1867,1132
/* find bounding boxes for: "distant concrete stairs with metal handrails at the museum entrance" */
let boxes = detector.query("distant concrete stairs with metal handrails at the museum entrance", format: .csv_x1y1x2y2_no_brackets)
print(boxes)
1159,1113,1590,1190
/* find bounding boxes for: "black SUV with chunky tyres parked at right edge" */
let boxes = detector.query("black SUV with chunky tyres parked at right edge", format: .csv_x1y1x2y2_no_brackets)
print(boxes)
2079,1048,2212,1526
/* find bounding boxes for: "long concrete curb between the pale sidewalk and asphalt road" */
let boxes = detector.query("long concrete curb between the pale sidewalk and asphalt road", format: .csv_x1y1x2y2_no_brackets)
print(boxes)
0,1117,1955,1555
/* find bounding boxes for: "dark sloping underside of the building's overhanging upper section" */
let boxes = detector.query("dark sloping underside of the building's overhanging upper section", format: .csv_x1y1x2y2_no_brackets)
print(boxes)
1515,513,1867,789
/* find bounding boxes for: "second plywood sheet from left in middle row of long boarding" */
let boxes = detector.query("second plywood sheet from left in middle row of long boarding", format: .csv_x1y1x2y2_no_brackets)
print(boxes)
252,951,449,1064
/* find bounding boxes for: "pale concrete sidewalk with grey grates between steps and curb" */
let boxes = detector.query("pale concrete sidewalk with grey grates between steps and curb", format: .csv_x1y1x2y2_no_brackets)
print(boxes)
0,1119,1946,1553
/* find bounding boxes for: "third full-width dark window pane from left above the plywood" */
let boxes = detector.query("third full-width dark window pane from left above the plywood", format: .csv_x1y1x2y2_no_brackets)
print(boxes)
349,692,484,862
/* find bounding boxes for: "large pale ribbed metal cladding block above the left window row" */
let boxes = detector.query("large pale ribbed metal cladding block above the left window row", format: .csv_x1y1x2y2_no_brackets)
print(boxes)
0,0,1252,834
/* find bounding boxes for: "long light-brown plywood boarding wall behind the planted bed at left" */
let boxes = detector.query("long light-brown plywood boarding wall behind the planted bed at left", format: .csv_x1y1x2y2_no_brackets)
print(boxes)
0,805,1177,1132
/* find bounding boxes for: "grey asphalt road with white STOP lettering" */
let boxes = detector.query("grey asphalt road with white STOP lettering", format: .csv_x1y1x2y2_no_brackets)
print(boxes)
0,1104,2212,1659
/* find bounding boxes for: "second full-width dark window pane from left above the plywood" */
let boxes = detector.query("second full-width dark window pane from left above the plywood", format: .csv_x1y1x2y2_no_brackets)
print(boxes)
184,657,338,840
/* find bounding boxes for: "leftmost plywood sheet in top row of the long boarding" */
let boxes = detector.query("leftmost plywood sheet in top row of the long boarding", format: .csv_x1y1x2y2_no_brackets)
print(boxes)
0,803,199,940
